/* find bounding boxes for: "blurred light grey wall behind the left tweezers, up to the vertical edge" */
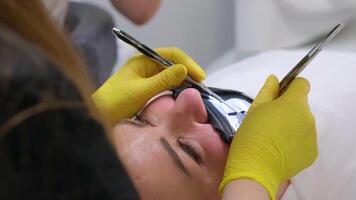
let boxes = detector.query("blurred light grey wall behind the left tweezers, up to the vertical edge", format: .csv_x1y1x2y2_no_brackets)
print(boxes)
82,0,234,67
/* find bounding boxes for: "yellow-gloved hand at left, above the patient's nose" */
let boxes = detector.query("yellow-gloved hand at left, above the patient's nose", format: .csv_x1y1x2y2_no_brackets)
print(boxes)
92,47,205,123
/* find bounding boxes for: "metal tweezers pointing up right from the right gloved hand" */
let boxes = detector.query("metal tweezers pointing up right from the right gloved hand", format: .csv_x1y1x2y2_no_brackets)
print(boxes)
279,23,345,94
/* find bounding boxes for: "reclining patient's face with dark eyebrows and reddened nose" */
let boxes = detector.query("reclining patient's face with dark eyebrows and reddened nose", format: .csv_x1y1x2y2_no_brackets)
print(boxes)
114,88,228,200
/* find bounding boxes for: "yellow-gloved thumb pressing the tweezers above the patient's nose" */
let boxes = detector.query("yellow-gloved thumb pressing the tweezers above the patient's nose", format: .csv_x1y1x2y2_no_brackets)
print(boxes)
147,64,187,94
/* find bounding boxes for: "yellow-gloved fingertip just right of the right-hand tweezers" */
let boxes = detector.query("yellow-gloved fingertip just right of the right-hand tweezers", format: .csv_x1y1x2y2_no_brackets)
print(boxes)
281,77,310,103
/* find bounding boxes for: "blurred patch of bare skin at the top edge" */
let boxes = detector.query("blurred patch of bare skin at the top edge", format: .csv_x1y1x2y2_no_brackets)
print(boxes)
111,0,161,25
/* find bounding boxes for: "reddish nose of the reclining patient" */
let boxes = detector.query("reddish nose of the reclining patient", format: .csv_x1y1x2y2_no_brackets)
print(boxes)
170,88,208,123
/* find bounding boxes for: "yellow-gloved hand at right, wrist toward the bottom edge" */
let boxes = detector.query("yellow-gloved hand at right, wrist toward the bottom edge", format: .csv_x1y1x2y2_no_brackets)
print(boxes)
219,76,318,199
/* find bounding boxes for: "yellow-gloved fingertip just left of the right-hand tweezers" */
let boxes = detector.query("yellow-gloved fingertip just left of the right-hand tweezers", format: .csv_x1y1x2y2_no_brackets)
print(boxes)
248,75,279,112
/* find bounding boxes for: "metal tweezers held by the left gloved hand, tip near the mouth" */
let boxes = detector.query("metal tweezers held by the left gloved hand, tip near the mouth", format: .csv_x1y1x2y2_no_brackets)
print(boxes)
112,28,238,112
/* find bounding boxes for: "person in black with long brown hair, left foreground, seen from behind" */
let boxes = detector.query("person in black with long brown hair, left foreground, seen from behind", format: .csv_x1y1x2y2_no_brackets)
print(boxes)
0,0,138,199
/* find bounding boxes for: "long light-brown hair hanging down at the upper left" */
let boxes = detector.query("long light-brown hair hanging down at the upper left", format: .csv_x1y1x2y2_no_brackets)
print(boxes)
0,0,107,130
